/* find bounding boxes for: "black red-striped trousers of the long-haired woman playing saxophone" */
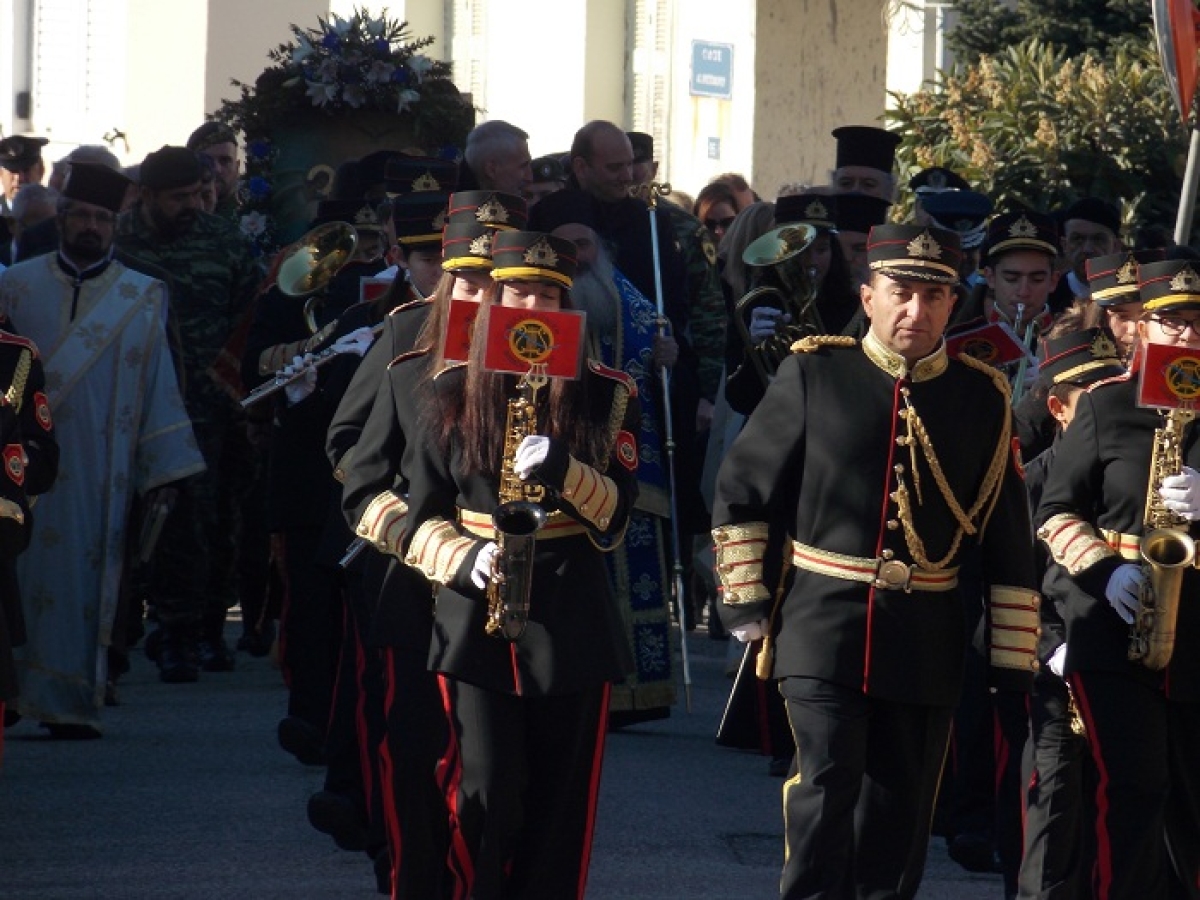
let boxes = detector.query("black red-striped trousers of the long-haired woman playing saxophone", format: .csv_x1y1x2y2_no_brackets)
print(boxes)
439,676,610,900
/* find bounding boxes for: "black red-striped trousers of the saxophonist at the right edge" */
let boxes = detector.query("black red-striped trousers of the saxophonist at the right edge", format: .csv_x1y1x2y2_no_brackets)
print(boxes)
1070,672,1200,900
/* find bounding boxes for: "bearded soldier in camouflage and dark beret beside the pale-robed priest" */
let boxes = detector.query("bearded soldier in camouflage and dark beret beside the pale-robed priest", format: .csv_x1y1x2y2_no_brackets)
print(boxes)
116,146,262,683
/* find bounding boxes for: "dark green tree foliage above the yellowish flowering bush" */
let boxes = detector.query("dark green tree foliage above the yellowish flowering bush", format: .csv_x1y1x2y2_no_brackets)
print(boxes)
946,0,1152,62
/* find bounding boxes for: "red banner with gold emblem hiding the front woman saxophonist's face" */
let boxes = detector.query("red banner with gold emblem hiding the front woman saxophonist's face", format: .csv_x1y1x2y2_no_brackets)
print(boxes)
484,306,587,378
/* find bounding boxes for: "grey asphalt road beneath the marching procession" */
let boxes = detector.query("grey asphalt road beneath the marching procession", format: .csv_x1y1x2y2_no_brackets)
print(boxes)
0,623,1003,900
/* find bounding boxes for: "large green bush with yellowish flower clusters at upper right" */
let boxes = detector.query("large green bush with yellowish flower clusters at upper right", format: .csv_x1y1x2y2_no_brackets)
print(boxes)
889,37,1188,237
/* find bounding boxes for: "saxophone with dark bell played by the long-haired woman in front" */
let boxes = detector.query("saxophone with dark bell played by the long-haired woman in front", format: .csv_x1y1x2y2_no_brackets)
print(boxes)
486,371,547,641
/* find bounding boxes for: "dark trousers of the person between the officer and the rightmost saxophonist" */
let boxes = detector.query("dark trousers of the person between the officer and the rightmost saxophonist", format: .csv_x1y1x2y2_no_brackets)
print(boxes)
1018,666,1096,900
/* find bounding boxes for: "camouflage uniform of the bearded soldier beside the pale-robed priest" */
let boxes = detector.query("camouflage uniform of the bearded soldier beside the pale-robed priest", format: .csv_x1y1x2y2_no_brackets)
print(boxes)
116,206,262,640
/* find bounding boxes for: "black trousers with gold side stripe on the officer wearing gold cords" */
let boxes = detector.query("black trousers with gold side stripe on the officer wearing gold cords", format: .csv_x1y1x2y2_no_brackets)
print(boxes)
780,678,954,900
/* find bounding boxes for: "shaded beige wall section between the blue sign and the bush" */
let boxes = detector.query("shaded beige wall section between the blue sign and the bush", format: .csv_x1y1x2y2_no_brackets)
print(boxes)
754,0,887,198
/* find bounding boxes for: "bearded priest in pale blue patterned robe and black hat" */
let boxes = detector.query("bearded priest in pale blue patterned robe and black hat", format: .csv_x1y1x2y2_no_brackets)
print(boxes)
0,163,204,738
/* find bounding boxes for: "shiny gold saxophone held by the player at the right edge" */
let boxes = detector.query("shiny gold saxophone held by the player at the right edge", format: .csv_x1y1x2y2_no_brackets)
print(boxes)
1129,409,1196,670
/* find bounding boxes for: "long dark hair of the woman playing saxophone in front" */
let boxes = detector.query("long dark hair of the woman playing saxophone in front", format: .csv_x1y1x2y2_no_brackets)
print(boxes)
424,283,611,476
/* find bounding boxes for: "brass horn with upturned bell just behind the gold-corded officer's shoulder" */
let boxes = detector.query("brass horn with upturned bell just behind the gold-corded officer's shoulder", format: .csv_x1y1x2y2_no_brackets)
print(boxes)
733,222,824,386
